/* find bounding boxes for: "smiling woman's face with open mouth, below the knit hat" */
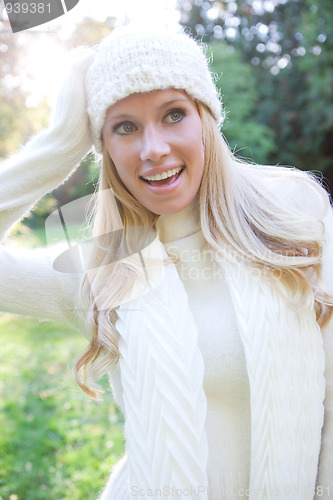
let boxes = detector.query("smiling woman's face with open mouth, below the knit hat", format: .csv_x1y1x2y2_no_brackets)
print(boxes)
103,89,204,215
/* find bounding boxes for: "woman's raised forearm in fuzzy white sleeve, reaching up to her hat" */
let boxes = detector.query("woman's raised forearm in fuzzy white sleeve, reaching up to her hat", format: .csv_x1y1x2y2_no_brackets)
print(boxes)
0,49,92,241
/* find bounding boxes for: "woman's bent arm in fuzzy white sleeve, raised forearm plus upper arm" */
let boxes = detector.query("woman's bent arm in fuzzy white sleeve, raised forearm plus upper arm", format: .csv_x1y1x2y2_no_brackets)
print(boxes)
0,49,93,324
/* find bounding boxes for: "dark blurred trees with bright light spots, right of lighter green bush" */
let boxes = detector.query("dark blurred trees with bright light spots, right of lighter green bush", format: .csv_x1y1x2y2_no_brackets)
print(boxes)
179,0,333,191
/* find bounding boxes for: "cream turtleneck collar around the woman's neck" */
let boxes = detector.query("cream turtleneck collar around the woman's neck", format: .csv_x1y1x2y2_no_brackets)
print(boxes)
156,197,200,243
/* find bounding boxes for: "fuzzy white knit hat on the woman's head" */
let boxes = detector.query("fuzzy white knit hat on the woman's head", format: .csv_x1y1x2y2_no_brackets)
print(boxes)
85,25,223,152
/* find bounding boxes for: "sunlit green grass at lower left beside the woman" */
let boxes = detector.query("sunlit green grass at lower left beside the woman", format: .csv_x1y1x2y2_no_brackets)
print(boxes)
0,314,124,500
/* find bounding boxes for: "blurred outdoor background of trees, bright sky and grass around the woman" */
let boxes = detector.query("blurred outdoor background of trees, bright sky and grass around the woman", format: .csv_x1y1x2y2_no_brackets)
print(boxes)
0,0,333,500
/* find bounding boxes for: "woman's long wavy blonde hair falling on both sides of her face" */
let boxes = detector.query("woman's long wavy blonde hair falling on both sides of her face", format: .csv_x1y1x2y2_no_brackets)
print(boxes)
74,102,332,398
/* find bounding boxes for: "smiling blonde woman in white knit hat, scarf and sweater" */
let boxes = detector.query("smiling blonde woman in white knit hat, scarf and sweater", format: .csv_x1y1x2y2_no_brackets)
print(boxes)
0,26,333,500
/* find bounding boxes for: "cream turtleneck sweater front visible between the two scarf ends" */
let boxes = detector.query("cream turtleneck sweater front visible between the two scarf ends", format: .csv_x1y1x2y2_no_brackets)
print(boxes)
157,208,251,500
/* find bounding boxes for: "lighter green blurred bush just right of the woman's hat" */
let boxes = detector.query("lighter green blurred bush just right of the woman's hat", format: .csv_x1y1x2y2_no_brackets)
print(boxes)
210,42,275,163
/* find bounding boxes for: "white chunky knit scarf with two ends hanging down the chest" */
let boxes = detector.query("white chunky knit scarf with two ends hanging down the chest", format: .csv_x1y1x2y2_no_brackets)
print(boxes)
116,240,325,500
